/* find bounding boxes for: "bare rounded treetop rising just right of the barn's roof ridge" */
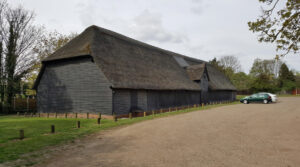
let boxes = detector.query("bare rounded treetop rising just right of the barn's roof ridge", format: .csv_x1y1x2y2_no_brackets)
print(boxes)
219,56,241,73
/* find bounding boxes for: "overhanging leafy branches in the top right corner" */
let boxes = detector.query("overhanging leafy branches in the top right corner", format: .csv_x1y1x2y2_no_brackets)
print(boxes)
248,0,300,59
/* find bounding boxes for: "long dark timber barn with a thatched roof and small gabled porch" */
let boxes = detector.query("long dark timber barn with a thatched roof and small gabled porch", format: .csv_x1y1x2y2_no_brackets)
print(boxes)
34,26,236,115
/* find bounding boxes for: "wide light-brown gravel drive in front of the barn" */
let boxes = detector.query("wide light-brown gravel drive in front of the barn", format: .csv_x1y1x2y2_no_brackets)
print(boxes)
37,98,300,167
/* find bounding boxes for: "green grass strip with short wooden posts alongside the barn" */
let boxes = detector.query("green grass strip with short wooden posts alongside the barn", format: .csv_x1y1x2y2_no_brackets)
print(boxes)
0,102,238,163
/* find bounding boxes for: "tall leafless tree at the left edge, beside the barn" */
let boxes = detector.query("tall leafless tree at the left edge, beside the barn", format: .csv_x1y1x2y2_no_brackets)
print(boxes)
0,2,41,105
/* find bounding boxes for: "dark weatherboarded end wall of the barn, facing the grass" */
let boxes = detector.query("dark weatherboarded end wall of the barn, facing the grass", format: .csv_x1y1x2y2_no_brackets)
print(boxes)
37,58,112,114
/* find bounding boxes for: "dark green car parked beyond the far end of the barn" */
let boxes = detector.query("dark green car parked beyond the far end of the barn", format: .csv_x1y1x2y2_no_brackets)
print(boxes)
240,93,272,104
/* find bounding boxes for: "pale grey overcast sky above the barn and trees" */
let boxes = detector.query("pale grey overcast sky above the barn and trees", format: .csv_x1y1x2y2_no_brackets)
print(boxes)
8,0,300,73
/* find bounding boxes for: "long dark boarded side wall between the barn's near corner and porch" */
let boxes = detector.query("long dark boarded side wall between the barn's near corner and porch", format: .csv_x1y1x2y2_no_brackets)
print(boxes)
113,89,200,115
